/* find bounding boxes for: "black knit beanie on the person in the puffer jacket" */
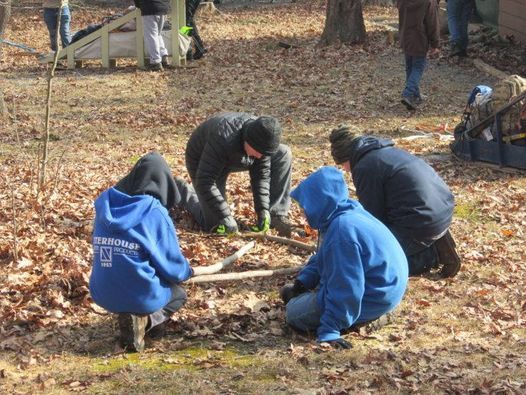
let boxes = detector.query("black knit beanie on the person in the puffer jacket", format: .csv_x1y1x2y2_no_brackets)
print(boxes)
243,117,281,155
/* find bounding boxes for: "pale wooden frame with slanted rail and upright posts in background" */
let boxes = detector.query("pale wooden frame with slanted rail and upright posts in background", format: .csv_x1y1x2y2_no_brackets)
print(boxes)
40,0,186,69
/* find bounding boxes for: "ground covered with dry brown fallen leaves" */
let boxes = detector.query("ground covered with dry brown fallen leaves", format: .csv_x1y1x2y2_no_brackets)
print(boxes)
0,1,526,393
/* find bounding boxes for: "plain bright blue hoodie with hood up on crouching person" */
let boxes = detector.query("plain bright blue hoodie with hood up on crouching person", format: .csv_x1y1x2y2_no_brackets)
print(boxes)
291,167,408,342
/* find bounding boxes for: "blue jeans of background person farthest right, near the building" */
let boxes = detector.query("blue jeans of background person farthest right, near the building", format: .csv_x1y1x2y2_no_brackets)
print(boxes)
447,0,475,51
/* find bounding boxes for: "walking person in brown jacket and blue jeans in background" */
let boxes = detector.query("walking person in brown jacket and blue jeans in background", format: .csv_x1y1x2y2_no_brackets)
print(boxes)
396,0,440,111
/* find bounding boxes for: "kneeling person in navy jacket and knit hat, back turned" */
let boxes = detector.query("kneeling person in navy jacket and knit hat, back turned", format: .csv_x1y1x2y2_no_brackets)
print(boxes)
330,127,461,277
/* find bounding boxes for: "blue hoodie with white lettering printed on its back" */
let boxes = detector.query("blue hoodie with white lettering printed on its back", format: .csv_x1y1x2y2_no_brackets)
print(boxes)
90,188,191,314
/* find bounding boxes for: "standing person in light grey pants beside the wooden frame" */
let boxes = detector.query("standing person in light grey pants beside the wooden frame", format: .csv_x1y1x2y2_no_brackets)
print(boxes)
134,0,170,71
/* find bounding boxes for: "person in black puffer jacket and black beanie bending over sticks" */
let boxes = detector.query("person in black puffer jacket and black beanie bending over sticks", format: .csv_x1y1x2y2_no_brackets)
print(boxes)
186,112,292,236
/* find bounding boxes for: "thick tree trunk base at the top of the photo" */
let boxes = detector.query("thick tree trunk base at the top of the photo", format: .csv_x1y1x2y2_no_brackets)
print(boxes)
320,0,365,46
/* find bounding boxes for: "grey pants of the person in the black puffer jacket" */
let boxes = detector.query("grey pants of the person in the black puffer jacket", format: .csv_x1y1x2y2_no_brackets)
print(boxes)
186,144,292,231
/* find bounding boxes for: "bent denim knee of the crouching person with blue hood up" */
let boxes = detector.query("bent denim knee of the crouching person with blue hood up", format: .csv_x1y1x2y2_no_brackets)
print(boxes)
286,292,321,332
